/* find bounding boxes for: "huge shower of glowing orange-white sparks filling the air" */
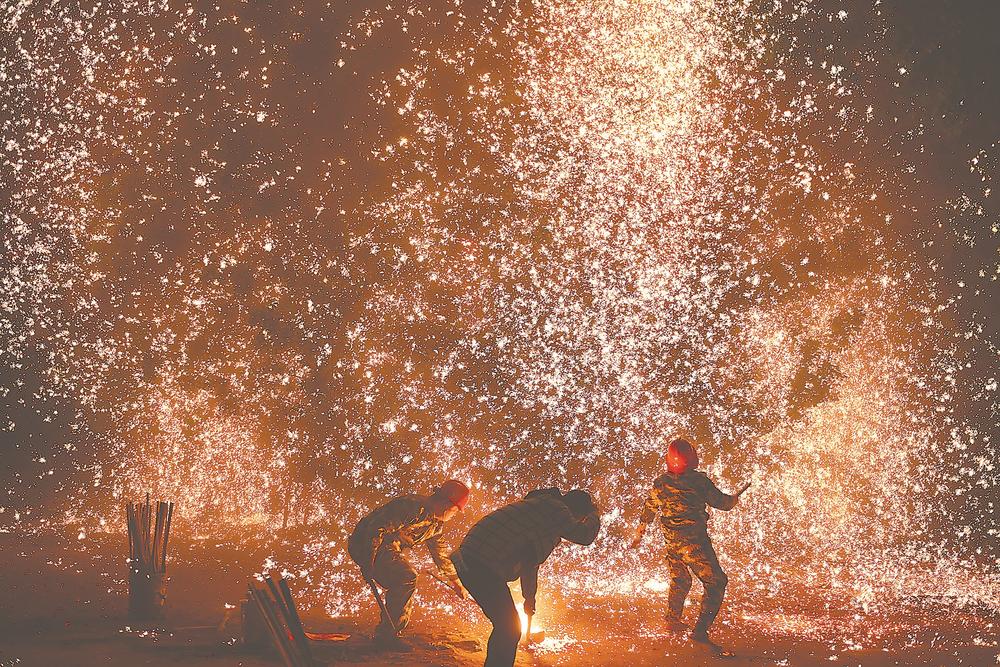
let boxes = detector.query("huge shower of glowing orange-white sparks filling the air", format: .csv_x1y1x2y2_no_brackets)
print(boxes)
0,0,1000,650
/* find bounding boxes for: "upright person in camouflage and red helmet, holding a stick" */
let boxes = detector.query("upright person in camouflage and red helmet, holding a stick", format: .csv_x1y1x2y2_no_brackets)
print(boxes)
630,438,750,655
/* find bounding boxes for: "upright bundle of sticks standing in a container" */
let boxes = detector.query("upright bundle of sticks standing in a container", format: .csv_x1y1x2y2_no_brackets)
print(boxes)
125,494,174,620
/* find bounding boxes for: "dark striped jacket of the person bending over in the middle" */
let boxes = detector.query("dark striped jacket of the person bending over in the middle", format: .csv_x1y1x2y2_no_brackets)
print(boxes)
452,492,601,581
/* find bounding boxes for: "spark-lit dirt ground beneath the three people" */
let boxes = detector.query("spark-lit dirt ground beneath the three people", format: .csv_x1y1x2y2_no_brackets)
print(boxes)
0,530,1000,667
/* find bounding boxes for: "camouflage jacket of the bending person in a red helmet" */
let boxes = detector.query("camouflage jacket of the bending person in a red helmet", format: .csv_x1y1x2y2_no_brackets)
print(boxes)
351,495,458,581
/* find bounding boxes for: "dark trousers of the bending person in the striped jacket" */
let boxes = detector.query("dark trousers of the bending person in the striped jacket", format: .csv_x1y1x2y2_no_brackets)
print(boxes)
455,558,521,667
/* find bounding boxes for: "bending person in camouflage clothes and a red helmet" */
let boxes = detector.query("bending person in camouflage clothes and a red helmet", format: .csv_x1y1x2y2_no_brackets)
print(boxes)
347,479,469,641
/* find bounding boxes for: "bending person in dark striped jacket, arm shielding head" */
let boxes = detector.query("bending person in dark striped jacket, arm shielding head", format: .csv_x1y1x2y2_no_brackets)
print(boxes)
451,488,601,667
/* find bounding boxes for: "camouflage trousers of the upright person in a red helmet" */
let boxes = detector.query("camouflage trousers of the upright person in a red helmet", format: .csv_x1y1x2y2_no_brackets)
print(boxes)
664,530,729,633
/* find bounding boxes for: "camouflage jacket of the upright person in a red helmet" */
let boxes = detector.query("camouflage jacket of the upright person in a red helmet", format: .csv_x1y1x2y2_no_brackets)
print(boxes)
639,470,737,531
